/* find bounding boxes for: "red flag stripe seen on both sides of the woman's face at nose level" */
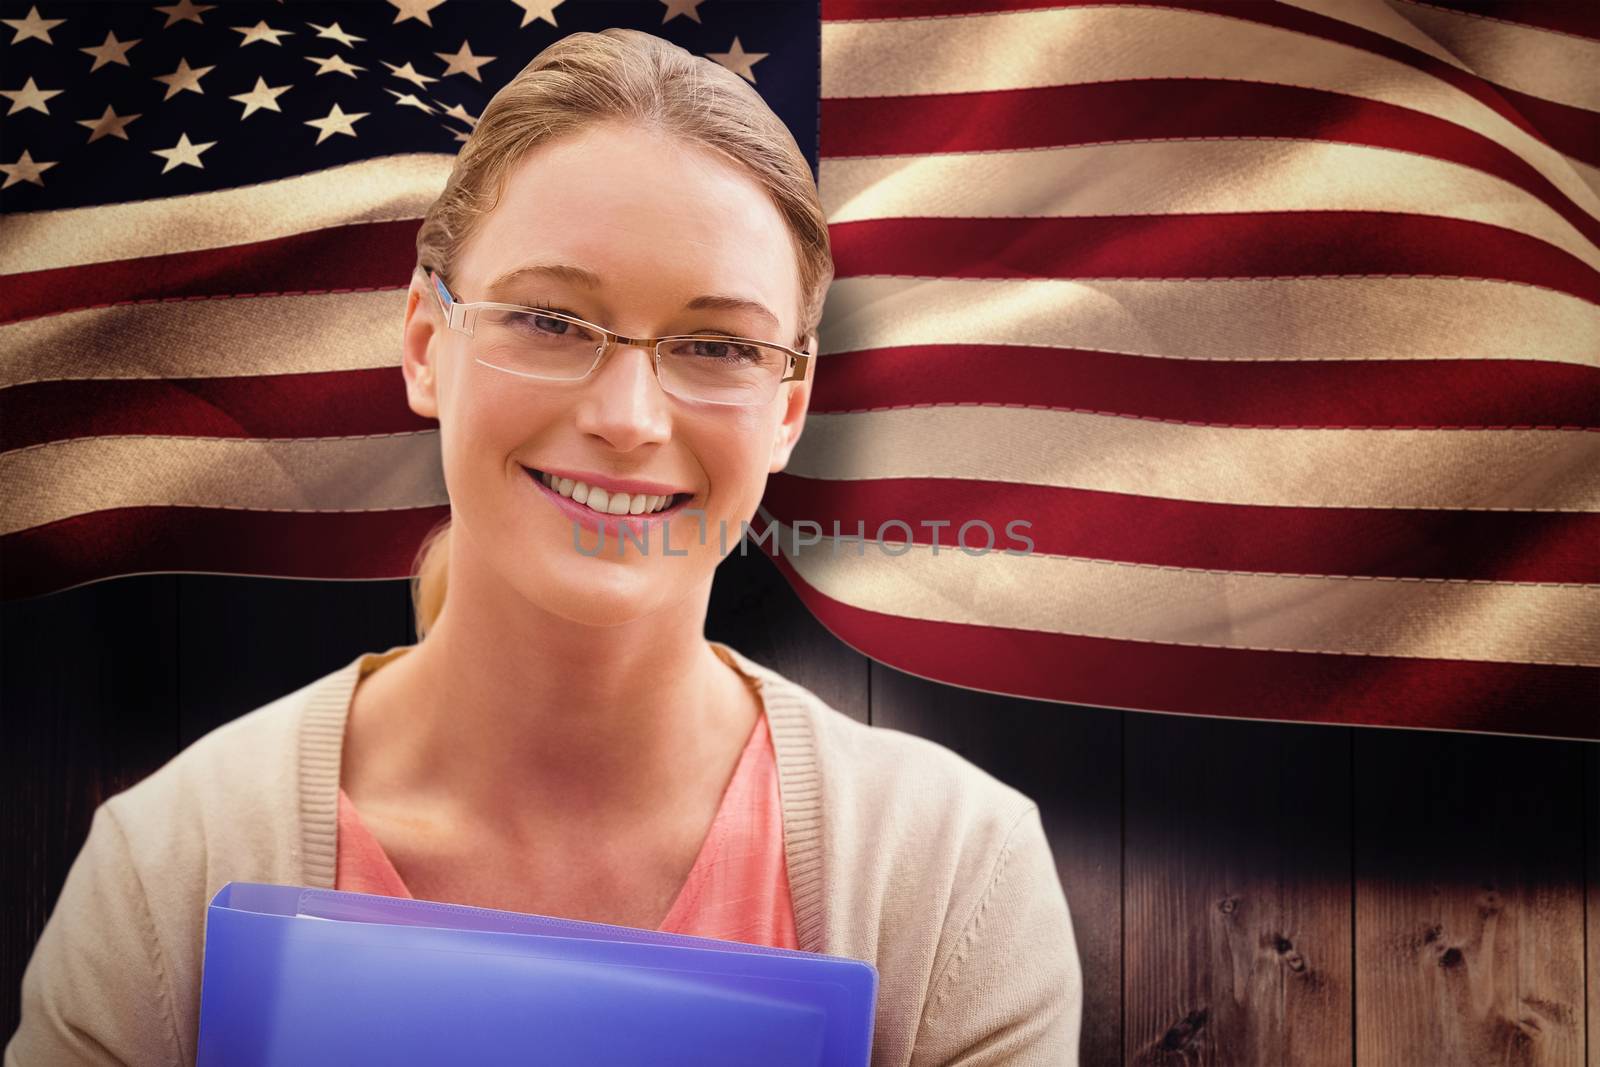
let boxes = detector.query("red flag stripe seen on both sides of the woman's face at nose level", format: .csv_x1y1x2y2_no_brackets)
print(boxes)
12,338,1600,460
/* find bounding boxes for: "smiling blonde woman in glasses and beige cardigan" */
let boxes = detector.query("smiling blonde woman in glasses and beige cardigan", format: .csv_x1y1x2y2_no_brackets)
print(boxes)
5,30,1082,1067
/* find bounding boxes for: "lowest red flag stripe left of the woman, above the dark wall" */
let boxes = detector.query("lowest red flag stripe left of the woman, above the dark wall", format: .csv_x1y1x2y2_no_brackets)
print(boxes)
0,506,450,600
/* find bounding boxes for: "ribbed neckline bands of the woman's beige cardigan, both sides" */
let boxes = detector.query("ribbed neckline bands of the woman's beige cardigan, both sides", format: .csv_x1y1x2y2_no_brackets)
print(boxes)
299,641,832,952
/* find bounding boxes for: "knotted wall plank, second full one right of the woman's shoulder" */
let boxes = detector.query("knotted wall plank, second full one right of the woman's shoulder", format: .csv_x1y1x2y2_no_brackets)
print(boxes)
1123,712,1354,1067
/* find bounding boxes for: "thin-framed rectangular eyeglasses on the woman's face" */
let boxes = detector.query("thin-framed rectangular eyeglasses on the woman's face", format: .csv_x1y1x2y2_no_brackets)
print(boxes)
424,267,811,405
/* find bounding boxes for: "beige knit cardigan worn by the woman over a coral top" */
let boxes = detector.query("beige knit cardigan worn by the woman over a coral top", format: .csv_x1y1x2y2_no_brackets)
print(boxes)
5,641,1083,1067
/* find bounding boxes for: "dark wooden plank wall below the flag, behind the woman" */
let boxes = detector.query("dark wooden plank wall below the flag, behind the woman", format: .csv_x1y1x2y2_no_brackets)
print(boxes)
0,557,1600,1067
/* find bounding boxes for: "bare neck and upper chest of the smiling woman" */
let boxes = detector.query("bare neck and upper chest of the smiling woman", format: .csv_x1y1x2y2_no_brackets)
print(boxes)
341,550,760,832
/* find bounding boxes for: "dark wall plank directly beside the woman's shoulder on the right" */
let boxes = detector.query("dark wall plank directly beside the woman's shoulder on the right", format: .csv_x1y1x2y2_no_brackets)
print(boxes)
872,664,1123,1067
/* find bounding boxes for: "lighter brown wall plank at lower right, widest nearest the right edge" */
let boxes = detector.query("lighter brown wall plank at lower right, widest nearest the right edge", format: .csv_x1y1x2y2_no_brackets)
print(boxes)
1355,731,1584,1067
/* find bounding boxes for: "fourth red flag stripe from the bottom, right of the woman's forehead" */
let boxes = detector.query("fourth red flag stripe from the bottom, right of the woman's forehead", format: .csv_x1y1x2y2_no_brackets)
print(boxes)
829,211,1600,304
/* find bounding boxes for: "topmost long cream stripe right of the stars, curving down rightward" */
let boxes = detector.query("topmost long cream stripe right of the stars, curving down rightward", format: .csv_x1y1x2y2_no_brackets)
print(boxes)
822,6,1600,223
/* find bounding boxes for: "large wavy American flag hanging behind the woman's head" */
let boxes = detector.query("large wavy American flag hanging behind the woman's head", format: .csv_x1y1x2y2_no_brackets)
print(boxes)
0,0,1600,739
